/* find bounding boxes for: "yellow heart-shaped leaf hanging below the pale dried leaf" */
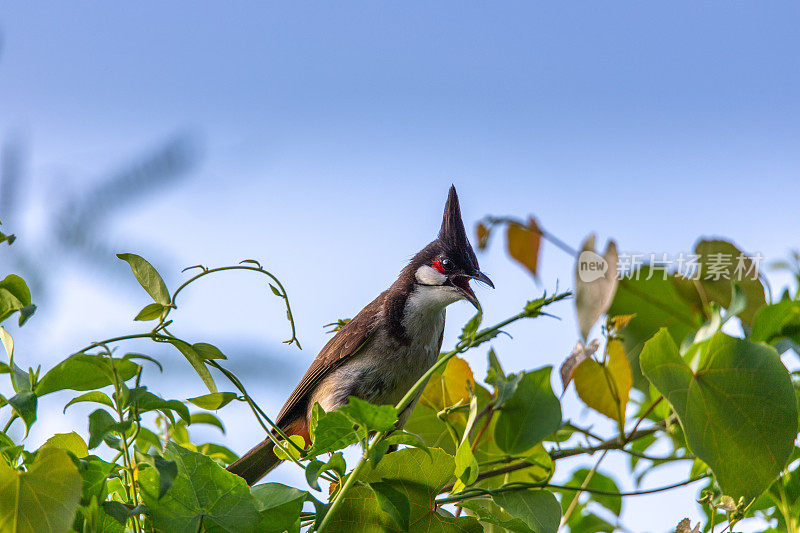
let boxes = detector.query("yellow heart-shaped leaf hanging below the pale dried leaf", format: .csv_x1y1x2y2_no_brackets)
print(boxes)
574,340,633,424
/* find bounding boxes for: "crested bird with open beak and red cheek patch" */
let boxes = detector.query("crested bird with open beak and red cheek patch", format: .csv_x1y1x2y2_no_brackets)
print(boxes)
227,185,494,485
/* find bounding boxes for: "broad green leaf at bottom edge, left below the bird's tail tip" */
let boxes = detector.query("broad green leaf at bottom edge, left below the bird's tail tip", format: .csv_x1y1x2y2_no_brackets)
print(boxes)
139,442,260,533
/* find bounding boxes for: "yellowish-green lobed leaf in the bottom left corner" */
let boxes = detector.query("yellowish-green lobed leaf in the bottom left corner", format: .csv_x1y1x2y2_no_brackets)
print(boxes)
0,448,81,533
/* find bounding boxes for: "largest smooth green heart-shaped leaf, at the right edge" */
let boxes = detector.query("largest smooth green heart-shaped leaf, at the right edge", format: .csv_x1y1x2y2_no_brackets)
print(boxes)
641,330,798,499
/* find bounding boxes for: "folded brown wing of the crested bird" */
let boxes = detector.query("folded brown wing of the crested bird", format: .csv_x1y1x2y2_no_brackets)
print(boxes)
276,293,386,427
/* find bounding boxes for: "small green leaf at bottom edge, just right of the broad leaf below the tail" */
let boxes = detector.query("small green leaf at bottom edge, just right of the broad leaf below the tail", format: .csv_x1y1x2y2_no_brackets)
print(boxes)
250,483,308,533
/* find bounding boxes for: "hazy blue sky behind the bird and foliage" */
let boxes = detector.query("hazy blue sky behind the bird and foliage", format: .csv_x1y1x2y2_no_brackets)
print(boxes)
0,2,800,531
